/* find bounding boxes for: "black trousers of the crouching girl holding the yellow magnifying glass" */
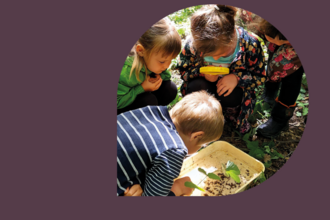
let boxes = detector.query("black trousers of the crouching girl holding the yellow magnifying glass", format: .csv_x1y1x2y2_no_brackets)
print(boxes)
187,78,243,108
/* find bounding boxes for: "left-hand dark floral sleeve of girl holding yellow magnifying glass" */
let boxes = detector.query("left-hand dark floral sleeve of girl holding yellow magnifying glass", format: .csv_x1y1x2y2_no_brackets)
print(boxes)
175,39,204,82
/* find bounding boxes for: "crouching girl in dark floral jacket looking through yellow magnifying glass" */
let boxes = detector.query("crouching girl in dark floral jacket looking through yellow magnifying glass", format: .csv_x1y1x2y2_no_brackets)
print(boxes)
176,5,266,134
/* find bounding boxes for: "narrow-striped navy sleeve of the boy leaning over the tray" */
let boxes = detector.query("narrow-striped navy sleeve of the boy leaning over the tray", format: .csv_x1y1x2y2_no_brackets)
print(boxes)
142,149,186,196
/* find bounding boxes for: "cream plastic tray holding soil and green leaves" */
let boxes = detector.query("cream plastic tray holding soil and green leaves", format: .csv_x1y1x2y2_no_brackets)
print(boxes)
178,141,265,196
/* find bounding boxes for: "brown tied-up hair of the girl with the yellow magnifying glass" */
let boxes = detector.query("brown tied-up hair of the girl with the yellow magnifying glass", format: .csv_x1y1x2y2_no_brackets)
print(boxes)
190,5,237,54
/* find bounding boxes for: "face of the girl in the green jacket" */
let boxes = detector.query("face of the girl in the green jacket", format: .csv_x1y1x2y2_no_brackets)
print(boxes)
144,52,175,74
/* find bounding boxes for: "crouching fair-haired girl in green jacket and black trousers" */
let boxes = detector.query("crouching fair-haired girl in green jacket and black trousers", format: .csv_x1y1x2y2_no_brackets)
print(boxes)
117,18,181,114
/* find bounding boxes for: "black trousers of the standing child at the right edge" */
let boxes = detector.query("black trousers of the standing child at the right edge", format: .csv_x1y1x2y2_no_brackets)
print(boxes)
265,66,304,106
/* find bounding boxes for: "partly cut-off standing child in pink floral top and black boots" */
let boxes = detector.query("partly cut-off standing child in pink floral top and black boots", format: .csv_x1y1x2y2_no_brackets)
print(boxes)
238,9,304,138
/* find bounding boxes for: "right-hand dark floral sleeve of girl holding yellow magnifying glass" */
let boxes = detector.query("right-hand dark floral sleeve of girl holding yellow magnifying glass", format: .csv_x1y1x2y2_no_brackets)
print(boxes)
235,35,266,90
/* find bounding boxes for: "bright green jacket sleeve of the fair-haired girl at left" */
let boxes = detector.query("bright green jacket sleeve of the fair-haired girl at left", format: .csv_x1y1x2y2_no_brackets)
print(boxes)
117,65,144,109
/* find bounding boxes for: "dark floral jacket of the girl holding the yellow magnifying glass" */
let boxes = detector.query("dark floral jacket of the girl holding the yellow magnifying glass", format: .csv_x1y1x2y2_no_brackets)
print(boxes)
176,27,266,134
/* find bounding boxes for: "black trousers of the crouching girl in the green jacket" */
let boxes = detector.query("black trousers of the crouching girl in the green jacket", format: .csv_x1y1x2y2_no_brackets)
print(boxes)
117,80,178,115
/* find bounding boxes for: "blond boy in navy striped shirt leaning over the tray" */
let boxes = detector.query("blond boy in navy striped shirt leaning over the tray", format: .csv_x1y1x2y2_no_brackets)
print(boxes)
117,91,224,196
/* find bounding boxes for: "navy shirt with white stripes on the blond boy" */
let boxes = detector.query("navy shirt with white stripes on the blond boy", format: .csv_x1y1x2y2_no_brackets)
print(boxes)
117,106,188,196
